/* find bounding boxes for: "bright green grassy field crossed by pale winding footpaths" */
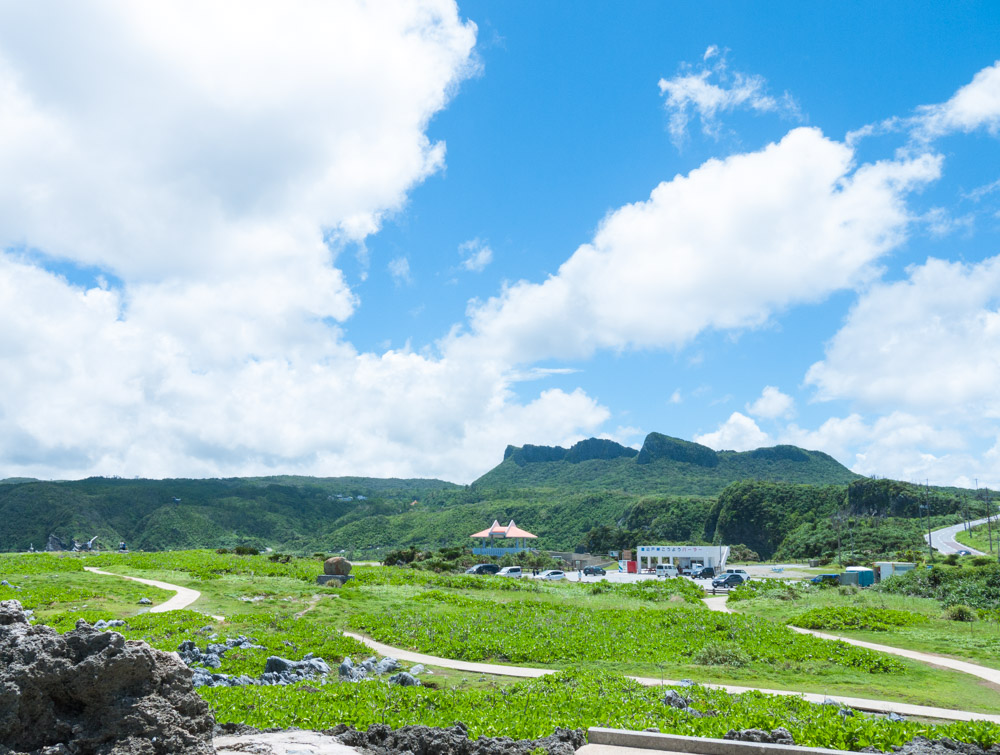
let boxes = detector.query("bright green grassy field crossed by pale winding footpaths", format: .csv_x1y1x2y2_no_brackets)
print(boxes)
0,551,1000,749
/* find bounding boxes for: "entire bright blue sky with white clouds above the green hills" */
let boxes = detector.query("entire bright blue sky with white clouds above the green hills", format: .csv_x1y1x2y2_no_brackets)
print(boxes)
0,0,1000,485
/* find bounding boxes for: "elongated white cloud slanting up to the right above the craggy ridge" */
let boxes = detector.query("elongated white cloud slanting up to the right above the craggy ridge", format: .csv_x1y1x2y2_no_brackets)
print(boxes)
456,128,940,370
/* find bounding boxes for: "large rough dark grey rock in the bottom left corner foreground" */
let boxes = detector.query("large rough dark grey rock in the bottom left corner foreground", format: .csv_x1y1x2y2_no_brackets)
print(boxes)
0,600,215,755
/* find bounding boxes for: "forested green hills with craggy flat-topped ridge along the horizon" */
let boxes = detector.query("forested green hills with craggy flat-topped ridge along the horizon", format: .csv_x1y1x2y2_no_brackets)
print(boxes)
0,433,984,559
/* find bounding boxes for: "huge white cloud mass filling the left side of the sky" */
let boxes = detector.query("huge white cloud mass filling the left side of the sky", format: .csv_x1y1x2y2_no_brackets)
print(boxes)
0,0,608,481
